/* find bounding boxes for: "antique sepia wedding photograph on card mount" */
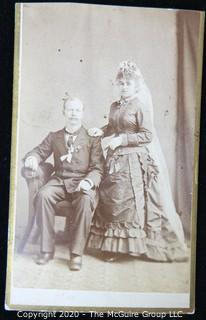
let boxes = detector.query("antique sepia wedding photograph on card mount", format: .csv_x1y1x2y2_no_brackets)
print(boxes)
5,3,204,313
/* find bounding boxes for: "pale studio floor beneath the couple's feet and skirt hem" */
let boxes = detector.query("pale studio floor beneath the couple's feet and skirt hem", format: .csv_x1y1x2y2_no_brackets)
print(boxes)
12,225,190,293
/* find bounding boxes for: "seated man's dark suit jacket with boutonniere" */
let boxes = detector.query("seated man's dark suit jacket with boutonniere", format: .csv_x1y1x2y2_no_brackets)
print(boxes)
24,126,104,193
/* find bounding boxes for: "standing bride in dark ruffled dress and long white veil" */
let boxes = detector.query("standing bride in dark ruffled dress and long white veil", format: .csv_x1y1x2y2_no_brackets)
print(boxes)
88,61,186,261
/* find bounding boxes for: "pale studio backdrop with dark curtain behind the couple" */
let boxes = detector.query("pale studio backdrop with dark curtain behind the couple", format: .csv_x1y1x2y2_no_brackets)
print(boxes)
16,3,200,236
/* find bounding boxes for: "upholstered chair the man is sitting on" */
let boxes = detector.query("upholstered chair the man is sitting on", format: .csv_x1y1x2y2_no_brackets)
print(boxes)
17,162,72,253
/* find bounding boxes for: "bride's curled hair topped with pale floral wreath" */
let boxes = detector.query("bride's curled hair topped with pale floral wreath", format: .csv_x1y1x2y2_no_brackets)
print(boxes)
116,60,142,82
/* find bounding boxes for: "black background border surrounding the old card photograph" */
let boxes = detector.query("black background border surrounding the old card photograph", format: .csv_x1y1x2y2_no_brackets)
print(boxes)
0,0,206,320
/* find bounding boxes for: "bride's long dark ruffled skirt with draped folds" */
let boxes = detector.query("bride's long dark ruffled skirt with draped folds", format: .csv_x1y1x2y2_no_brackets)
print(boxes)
87,152,186,261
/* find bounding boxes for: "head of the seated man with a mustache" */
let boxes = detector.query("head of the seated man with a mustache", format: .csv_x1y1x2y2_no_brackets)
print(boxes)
63,100,83,126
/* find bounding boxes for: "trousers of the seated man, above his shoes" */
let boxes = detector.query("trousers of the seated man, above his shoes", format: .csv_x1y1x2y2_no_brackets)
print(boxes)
34,184,96,255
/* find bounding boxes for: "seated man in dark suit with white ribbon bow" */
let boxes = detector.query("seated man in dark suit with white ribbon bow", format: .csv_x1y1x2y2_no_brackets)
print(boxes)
24,96,104,270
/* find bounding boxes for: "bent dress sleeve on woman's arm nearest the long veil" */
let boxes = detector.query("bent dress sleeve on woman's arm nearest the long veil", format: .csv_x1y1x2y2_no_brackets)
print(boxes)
121,107,153,147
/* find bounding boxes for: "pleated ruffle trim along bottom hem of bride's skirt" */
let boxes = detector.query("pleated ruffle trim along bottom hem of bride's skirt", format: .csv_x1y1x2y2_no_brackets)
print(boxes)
87,222,187,262
